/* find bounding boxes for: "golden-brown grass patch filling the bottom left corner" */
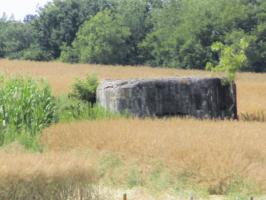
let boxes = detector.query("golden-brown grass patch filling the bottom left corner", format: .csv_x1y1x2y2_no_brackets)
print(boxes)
0,152,97,200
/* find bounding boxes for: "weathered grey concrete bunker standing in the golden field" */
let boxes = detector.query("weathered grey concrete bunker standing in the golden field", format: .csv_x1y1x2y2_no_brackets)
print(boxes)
97,78,237,119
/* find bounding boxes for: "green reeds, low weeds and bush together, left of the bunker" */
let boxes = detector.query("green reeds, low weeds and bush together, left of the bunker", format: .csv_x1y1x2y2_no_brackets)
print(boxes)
0,76,118,151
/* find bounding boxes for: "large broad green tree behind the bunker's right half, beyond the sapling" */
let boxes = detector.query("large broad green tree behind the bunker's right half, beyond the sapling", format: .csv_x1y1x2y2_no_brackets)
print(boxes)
141,0,257,69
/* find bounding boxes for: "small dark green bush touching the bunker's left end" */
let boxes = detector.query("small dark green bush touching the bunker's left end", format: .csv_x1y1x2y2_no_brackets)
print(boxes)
69,75,98,104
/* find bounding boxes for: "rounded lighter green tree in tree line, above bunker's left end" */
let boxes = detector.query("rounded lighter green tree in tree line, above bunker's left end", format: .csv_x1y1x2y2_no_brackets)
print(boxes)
69,10,130,64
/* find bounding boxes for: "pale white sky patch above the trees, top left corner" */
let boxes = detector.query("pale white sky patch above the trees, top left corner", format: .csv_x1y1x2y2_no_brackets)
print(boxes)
0,0,52,20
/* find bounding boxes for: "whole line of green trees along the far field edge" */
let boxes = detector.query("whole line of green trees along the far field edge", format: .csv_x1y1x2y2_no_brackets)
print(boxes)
0,0,266,72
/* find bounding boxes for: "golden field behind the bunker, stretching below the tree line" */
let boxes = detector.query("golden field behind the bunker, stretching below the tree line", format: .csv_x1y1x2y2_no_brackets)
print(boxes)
0,59,266,113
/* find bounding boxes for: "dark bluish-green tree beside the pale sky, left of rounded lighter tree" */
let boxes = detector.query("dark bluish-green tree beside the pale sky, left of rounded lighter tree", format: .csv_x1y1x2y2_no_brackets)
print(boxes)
34,0,111,58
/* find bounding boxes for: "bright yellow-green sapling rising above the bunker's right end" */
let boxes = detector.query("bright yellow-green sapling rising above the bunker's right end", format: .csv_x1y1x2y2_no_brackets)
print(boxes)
206,38,249,81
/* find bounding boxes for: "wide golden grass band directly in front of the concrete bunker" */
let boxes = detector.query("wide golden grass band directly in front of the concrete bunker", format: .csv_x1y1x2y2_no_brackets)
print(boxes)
42,118,266,193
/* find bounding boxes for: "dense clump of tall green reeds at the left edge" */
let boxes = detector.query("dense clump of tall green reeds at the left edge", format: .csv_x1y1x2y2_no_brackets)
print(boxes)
0,77,57,145
